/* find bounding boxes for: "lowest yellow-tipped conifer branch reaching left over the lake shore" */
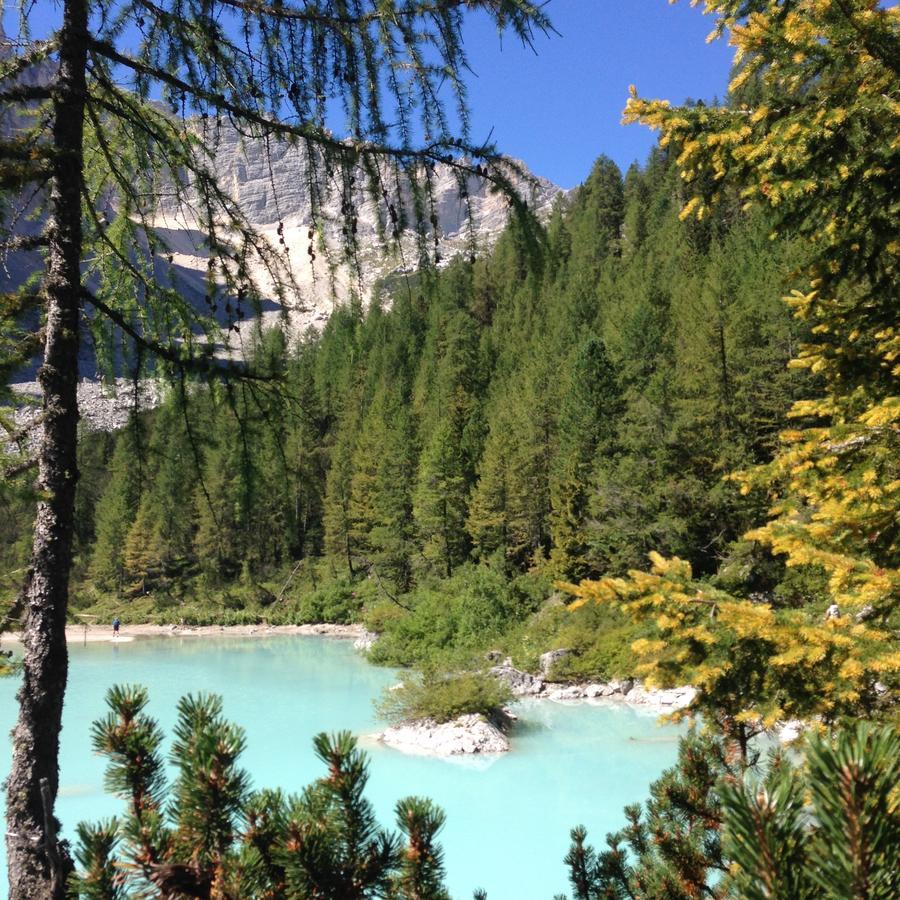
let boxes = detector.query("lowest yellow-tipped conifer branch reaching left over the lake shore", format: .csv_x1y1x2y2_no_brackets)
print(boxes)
570,553,900,725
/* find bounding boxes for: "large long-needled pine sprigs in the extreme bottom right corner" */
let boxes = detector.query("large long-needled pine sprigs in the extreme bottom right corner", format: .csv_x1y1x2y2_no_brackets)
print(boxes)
722,722,900,900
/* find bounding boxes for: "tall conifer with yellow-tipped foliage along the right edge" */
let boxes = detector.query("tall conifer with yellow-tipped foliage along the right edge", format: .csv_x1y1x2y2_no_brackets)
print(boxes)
572,0,900,722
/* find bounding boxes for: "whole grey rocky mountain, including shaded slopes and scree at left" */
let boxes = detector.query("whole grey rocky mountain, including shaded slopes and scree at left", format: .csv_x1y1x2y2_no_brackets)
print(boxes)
0,30,563,428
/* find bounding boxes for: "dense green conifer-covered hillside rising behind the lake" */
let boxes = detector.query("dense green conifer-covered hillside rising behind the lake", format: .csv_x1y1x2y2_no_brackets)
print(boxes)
0,150,811,684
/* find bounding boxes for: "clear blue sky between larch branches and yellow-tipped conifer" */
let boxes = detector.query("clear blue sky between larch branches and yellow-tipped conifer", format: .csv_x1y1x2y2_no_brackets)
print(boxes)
0,0,731,188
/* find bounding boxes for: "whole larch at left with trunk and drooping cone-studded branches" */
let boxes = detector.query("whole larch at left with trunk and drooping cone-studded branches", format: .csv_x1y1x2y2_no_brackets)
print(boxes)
0,0,547,884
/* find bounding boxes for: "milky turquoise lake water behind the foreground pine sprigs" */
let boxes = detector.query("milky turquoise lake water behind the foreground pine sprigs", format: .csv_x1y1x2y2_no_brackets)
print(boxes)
0,636,678,900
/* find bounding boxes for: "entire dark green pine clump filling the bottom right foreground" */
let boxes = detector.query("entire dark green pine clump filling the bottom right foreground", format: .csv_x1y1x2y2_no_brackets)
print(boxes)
565,722,900,900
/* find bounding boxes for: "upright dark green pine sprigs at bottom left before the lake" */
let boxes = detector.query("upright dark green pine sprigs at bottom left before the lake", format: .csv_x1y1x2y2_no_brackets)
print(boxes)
71,687,458,900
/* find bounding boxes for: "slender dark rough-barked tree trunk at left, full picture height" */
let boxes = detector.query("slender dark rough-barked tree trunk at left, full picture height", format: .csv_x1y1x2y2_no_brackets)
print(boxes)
6,0,88,900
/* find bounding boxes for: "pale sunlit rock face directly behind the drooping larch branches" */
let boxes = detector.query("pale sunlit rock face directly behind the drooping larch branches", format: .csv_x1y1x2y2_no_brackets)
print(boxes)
156,126,562,333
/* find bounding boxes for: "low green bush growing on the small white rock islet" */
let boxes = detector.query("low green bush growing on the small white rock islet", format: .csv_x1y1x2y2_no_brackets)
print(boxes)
378,672,512,722
